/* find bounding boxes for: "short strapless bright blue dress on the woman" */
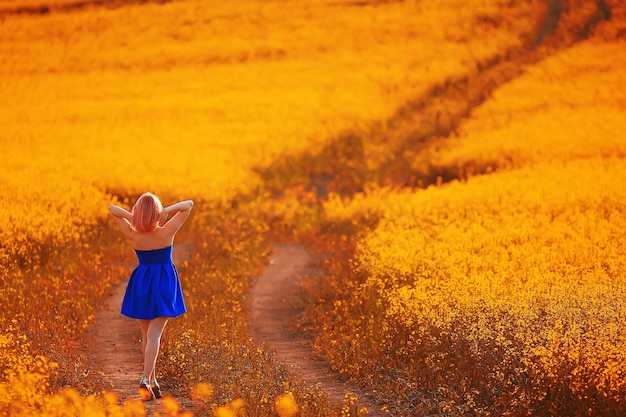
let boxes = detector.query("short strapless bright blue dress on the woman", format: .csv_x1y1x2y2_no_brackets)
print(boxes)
122,246,187,320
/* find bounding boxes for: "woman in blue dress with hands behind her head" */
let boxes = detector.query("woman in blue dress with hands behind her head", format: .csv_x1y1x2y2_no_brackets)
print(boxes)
109,193,193,400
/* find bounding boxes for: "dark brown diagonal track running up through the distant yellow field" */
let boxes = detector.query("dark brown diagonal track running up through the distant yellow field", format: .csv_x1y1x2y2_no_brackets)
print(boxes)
258,0,612,198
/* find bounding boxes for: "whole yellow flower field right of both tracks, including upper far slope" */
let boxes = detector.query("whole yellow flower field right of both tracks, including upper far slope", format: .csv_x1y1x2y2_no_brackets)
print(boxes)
286,4,626,415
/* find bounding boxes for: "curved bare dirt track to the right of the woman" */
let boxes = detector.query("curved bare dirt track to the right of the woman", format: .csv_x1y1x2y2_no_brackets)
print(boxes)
248,243,388,416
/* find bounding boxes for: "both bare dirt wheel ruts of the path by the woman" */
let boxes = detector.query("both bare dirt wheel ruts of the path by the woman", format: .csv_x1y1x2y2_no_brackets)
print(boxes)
87,243,385,416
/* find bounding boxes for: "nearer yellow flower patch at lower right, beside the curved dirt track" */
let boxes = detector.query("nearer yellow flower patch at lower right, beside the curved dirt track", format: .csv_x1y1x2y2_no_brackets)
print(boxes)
309,159,626,415
